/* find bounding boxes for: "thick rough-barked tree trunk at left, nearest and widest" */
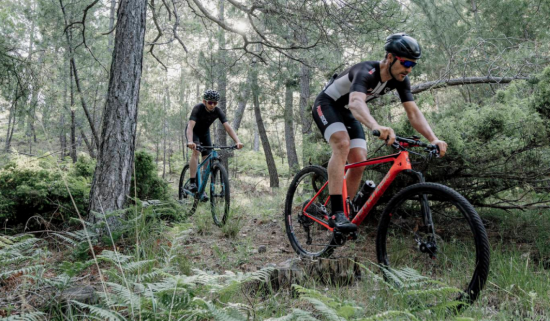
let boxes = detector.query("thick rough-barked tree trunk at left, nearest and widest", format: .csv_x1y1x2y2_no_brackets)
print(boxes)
89,0,147,228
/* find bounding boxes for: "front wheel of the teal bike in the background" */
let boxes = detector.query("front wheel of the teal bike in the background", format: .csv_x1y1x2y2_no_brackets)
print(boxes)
210,164,230,227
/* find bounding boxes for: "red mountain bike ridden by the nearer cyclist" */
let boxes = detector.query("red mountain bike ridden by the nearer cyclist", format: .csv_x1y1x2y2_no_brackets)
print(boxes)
285,131,490,303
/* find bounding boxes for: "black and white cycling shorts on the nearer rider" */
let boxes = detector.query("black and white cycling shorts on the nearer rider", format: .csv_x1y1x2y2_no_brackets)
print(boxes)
311,92,367,149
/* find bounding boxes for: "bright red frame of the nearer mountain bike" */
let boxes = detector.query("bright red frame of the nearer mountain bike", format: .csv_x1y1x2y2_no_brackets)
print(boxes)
302,151,412,231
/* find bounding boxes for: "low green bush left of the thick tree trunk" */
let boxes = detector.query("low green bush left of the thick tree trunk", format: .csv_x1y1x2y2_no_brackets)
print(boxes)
0,156,91,227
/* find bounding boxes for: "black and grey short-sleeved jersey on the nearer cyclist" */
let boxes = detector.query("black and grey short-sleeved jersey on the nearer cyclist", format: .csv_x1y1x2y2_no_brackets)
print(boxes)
324,61,414,107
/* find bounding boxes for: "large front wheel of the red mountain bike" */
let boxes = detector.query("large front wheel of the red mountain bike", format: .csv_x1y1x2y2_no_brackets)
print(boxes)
376,183,490,308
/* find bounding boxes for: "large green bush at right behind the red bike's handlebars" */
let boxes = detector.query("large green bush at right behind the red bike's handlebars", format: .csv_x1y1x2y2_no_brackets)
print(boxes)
394,69,550,207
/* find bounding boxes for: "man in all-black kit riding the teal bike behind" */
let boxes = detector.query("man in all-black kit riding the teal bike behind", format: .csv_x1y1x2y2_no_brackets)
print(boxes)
185,89,243,192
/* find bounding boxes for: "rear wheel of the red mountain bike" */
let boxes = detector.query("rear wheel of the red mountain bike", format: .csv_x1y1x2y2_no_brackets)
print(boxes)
284,166,336,257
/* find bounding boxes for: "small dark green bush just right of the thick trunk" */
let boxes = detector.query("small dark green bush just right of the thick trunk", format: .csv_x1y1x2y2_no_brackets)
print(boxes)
130,151,170,200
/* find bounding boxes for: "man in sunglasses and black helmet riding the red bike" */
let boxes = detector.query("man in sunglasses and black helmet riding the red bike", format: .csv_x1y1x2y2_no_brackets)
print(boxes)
312,33,447,232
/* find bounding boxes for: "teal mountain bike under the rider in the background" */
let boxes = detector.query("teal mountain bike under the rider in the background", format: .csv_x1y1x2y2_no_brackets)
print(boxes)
178,146,237,226
